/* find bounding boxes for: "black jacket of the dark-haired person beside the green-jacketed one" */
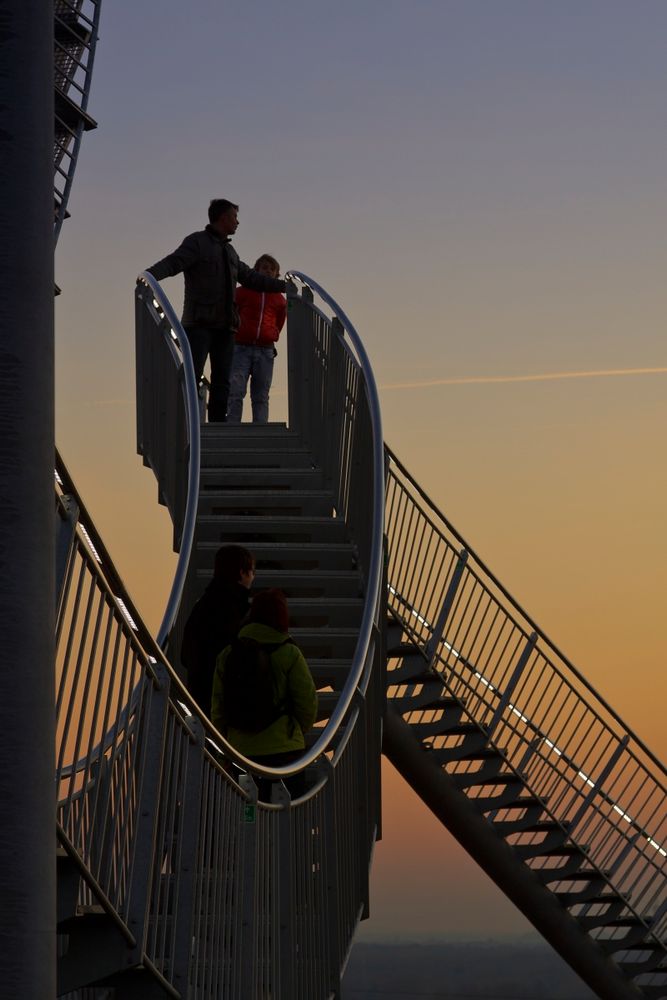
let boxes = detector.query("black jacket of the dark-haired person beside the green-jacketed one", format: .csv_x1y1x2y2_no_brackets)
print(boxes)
181,578,250,715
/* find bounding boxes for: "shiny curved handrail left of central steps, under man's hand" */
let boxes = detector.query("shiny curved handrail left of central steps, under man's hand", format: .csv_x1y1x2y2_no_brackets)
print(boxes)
137,271,201,649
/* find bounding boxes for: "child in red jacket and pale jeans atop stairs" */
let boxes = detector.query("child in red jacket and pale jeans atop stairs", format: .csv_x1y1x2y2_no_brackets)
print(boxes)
227,253,287,424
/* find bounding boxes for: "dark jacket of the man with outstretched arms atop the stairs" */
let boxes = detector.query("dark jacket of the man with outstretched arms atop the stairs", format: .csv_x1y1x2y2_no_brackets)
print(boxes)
148,226,285,330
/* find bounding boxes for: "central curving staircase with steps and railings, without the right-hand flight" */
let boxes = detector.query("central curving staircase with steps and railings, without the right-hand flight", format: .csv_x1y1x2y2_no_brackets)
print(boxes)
56,281,385,1000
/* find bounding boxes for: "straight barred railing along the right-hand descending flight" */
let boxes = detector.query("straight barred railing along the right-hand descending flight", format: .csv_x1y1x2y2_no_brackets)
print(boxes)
386,449,667,956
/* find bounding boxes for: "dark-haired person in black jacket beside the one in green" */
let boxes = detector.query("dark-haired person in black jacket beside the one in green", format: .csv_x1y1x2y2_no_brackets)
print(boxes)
181,545,255,715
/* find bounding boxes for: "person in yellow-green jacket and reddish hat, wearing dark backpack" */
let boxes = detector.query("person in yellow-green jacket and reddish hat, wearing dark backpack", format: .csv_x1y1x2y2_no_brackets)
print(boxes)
211,590,317,797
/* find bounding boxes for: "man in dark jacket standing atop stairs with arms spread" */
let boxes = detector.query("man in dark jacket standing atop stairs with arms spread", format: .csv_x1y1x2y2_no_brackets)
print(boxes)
148,198,285,421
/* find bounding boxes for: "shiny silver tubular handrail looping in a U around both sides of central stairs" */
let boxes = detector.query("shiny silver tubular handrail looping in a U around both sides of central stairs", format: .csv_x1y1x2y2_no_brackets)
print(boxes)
137,271,384,780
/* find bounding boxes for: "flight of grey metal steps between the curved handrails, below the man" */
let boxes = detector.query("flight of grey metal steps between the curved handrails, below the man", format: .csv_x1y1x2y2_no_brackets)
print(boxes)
170,424,364,736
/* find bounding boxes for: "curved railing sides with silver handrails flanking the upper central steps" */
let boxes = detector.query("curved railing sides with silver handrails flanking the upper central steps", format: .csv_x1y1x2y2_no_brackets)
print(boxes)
135,272,384,777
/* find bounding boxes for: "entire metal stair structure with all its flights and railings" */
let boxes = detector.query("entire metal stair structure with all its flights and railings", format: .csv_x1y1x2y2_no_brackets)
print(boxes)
54,0,667,1000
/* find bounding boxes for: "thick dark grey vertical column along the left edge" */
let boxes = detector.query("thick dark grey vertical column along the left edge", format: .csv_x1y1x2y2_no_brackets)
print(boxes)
0,0,56,1000
